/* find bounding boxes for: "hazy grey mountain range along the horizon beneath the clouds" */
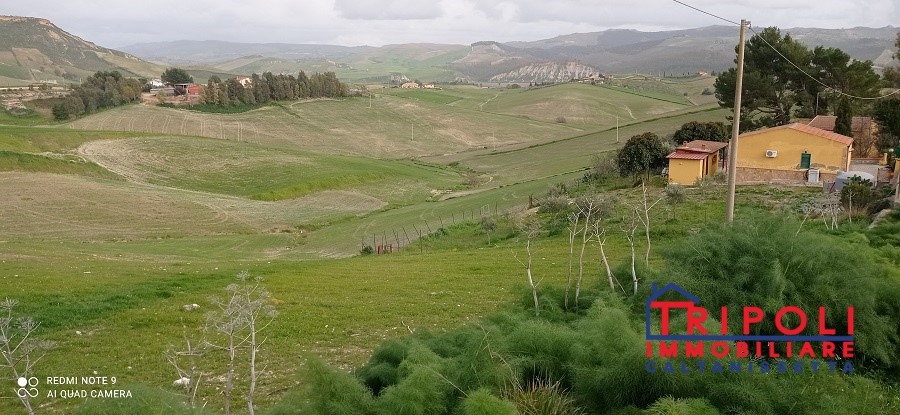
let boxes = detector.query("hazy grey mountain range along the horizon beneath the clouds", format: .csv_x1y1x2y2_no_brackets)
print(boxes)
123,26,898,82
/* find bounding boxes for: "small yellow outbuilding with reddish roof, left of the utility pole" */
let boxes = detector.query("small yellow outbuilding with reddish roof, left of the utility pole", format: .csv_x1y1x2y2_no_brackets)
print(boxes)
666,140,728,185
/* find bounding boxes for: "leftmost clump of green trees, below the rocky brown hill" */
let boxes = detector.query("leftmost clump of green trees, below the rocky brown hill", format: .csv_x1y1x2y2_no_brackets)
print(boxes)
52,71,142,120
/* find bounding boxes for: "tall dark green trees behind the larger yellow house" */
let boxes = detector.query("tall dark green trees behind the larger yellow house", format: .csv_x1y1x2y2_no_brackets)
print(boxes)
715,27,900,159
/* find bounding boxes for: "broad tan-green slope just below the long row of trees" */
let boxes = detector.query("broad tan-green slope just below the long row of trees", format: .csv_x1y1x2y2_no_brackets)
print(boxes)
68,94,572,158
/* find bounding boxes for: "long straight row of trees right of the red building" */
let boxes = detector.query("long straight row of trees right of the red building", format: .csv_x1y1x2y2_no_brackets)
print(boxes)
202,71,348,105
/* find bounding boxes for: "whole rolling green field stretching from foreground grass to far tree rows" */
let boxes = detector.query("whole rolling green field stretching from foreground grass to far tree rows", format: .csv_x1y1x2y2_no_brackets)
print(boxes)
0,81,896,413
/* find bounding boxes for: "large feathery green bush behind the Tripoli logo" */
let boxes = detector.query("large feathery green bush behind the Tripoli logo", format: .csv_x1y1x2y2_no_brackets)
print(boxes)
665,218,900,368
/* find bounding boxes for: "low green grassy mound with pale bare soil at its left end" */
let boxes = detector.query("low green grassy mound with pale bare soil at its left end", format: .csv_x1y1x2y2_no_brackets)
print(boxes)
79,137,462,203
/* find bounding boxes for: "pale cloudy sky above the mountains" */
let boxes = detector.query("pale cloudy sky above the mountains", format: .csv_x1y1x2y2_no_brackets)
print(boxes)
0,0,900,48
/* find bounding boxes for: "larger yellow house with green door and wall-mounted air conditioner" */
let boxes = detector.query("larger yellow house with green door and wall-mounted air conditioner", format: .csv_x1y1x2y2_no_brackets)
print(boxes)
737,123,853,183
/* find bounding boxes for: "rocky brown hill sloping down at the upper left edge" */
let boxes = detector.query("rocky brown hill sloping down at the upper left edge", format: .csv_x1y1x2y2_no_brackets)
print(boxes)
0,16,165,84
